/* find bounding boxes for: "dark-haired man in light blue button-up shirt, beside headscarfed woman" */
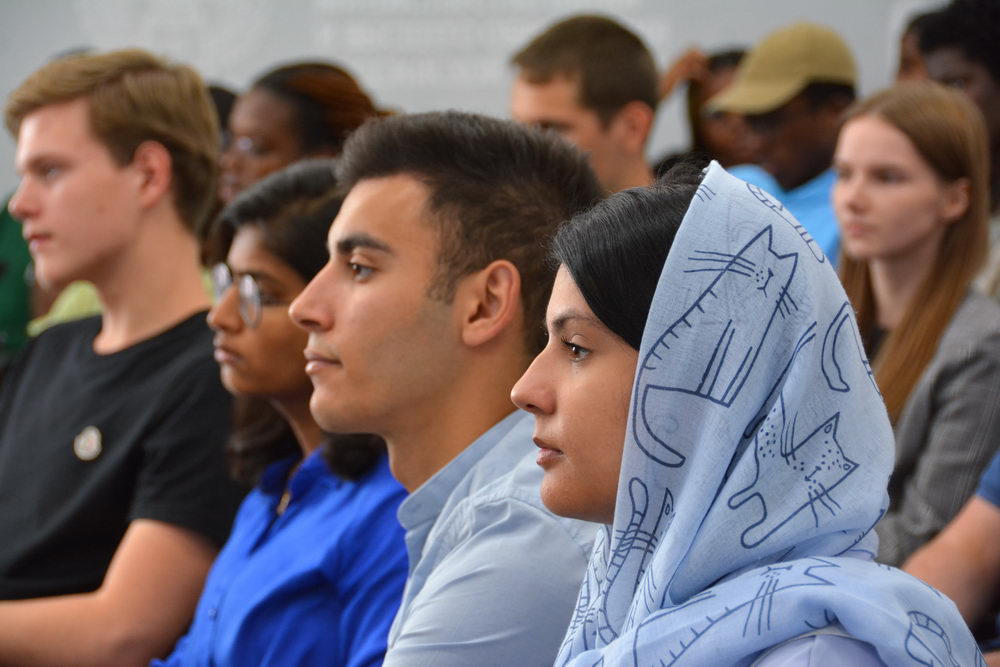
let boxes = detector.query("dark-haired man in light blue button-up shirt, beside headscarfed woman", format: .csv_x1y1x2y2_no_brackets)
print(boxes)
291,112,600,667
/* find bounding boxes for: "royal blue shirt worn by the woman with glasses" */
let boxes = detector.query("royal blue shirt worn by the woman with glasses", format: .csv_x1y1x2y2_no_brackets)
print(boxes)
153,451,407,667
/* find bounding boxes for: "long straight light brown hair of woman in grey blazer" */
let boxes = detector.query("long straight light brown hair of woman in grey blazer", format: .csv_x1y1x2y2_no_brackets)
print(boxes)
840,83,990,421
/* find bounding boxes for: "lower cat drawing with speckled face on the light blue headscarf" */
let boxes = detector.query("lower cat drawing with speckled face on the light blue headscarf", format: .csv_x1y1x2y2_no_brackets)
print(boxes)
728,395,858,549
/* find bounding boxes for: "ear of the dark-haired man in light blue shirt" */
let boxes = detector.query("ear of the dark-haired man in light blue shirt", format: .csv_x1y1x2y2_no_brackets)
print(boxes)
455,259,521,347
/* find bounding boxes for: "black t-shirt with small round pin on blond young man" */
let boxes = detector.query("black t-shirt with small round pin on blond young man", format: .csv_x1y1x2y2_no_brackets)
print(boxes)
0,313,243,599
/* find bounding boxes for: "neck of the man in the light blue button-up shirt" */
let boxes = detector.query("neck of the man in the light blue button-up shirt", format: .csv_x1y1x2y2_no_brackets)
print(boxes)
380,352,527,493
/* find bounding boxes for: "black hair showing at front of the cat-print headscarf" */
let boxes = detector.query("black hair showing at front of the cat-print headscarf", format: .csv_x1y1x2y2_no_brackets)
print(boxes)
551,159,704,350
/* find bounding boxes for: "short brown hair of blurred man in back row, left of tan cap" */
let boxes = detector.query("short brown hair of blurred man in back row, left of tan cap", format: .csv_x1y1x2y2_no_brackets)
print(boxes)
511,15,659,124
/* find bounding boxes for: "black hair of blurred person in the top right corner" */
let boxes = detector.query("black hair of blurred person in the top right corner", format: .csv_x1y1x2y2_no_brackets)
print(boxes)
919,0,1000,82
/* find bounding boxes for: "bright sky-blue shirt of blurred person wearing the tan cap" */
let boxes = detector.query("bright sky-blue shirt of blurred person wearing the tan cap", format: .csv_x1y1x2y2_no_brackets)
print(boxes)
726,164,840,266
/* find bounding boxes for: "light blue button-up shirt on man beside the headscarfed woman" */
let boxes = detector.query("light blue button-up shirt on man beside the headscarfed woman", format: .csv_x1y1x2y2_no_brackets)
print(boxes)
384,411,597,667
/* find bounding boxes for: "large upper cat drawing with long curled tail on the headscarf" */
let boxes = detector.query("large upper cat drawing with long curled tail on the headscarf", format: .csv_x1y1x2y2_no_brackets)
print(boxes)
632,226,798,467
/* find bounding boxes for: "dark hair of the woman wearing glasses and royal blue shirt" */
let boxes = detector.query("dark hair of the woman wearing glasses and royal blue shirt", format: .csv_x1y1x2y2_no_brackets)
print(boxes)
209,159,385,484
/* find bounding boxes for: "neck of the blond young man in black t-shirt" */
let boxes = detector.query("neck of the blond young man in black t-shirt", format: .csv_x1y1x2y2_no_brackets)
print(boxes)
93,205,211,354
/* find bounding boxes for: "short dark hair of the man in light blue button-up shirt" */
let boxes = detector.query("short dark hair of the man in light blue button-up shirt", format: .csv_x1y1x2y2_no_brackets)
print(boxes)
338,111,602,354
